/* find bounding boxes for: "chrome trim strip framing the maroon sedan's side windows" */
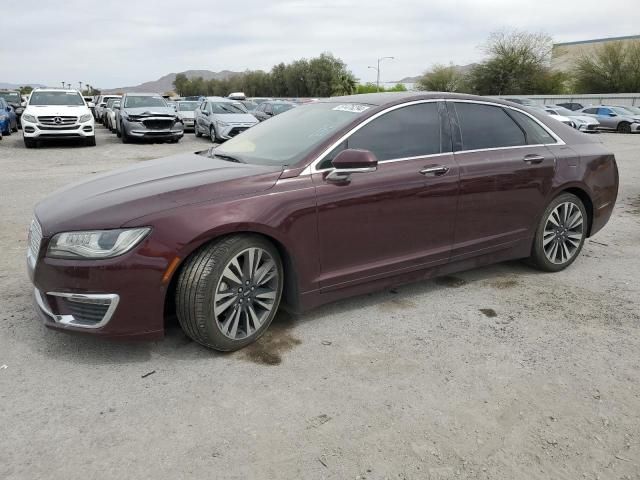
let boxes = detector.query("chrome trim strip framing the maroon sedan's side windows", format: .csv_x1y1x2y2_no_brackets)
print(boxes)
299,98,566,176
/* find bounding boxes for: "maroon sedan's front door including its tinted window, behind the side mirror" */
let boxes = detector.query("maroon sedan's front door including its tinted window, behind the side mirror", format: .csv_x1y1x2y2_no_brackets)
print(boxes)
313,101,458,291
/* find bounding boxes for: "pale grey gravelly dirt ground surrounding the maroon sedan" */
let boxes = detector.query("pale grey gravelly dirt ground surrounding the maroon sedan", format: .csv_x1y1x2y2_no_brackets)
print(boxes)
0,125,640,480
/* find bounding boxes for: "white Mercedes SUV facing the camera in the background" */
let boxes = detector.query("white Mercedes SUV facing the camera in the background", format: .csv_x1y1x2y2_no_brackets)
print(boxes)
22,88,96,148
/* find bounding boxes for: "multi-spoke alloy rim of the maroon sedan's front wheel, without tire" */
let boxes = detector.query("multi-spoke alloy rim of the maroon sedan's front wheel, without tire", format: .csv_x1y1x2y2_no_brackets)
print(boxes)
213,247,280,340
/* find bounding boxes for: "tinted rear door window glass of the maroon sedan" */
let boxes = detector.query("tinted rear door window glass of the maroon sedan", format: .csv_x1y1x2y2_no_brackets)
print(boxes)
456,103,527,150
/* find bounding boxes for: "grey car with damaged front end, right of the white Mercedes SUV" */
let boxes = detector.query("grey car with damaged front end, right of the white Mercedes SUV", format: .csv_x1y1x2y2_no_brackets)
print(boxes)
115,93,184,143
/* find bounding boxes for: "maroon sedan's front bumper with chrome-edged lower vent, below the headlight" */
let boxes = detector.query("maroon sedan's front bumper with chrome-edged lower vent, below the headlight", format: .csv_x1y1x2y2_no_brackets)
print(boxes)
27,222,169,340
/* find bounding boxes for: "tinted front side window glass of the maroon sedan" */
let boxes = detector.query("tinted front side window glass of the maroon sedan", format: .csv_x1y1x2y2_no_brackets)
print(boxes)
347,102,441,161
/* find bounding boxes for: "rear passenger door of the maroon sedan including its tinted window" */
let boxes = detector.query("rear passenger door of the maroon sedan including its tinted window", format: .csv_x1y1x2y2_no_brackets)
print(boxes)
448,101,556,261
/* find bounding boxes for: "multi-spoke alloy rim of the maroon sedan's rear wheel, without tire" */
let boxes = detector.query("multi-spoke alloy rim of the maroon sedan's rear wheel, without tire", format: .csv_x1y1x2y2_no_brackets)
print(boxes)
542,202,584,265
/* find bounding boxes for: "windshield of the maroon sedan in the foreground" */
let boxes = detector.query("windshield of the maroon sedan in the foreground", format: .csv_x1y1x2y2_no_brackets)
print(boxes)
213,103,371,166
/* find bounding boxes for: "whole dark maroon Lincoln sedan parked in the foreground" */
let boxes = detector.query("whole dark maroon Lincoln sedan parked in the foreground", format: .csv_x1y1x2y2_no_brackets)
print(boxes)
28,93,618,350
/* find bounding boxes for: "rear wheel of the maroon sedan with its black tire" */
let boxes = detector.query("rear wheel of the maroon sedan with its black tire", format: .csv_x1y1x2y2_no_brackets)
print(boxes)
529,193,589,272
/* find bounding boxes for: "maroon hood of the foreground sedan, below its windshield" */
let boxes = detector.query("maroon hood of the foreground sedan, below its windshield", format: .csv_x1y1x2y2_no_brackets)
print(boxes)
35,153,282,235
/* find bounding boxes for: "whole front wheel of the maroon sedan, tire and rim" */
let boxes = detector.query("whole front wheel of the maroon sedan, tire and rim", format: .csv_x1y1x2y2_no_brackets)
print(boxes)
176,235,283,351
